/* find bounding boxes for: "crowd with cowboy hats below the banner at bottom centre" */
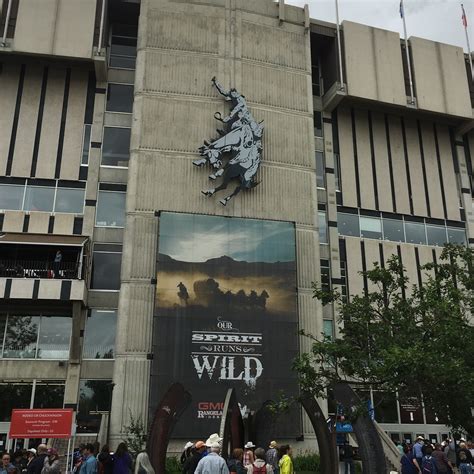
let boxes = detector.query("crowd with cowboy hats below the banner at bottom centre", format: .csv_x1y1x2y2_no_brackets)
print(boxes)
181,433,293,474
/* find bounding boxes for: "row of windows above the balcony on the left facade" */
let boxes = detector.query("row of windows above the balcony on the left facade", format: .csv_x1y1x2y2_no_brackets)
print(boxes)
0,180,85,214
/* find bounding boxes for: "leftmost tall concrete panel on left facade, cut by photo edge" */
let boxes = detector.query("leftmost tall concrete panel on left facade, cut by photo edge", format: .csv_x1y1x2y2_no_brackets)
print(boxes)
0,62,20,175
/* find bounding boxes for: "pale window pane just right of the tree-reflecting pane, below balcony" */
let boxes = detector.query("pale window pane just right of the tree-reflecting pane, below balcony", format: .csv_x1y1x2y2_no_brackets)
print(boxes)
37,316,72,359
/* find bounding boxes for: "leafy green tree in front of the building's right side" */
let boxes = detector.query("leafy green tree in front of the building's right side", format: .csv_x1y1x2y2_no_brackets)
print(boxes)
294,245,474,433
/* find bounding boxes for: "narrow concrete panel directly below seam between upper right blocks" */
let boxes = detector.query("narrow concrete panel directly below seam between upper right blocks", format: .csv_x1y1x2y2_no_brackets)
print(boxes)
405,118,428,216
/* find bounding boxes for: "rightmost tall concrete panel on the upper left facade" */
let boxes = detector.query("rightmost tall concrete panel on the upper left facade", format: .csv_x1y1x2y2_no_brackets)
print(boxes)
61,69,88,179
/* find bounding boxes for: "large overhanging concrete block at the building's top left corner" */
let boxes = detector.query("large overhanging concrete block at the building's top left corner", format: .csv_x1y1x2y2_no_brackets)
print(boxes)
12,0,97,58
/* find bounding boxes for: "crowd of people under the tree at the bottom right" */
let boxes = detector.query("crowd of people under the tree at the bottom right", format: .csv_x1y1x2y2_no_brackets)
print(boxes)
397,436,474,474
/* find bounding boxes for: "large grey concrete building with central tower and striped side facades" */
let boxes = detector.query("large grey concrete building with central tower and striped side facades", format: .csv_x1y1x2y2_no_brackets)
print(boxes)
0,0,474,456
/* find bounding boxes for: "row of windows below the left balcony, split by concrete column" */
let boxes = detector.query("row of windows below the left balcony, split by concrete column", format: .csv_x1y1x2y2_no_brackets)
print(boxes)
0,309,117,360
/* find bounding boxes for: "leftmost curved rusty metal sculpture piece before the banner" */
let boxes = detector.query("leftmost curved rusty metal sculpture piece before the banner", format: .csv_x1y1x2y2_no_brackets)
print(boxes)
147,383,191,474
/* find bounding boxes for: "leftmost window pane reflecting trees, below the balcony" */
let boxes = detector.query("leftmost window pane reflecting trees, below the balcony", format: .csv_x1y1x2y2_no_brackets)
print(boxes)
3,315,40,359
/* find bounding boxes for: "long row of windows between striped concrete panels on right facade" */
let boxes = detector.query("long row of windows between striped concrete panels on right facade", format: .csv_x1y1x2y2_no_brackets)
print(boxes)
337,212,466,246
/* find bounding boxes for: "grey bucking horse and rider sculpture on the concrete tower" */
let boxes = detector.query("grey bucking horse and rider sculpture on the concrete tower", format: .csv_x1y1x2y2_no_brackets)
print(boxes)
193,77,263,206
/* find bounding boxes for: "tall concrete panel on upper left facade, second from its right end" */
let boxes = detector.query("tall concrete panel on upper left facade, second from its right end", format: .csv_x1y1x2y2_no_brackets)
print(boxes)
36,67,66,178
